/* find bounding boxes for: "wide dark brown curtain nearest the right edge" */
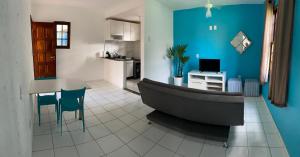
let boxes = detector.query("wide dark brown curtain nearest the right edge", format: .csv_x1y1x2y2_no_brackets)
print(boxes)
269,0,295,107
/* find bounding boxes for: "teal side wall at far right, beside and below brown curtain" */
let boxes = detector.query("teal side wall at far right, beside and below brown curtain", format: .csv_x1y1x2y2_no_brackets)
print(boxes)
263,1,300,157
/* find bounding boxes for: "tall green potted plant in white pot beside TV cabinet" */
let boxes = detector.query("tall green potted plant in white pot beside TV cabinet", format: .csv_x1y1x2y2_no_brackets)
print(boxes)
167,45,190,86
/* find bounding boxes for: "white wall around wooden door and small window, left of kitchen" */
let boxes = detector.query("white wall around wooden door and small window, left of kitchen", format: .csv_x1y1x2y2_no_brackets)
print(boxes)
32,4,105,80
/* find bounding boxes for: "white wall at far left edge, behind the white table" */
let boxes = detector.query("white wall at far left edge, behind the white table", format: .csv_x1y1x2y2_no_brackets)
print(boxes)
0,0,33,157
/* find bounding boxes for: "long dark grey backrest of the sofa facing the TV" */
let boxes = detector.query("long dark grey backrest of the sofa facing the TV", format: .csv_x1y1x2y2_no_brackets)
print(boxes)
138,79,244,144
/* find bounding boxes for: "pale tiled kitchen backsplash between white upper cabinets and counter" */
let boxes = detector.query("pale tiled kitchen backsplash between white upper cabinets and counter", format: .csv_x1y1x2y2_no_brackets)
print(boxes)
105,40,141,59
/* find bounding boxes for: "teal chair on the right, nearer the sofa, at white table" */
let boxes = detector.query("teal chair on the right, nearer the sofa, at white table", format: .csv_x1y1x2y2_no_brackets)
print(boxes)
58,88,86,135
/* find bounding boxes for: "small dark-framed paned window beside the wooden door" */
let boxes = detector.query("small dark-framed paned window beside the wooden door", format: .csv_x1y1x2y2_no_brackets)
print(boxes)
55,22,71,49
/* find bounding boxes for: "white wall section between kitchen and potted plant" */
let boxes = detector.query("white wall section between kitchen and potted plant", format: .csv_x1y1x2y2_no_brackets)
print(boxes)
144,0,173,83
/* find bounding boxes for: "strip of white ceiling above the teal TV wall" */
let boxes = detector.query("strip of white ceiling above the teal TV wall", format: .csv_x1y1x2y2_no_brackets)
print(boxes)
159,0,265,10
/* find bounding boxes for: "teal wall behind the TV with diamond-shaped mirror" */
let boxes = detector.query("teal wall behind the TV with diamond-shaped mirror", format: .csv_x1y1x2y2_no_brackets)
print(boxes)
174,4,265,81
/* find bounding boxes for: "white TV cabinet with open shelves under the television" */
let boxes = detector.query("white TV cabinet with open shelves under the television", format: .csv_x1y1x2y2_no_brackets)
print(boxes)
188,70,226,92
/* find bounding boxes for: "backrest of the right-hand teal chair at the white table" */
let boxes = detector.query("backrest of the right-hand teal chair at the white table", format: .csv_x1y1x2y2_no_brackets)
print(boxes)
61,87,86,105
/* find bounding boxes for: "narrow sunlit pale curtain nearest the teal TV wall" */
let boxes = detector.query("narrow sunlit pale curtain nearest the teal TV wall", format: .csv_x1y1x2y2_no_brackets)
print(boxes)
260,0,275,84
